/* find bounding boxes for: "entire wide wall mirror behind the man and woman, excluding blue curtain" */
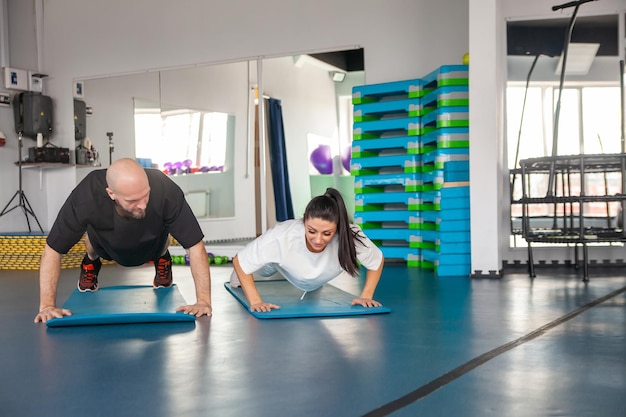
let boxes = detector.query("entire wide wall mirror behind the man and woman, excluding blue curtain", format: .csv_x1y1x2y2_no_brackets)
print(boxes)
73,49,365,241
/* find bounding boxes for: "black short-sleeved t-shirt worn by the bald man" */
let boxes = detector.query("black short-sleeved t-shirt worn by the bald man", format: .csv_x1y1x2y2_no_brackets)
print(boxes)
46,169,204,266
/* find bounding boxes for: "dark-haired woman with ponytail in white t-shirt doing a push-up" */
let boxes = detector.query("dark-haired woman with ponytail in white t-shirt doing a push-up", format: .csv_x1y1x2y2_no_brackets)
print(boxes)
230,188,384,312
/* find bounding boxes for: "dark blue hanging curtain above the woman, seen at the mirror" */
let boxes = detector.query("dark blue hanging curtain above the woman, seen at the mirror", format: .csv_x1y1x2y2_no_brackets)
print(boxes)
266,98,294,222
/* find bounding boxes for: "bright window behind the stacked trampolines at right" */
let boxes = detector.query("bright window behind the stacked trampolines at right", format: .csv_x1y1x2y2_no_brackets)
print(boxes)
506,85,621,247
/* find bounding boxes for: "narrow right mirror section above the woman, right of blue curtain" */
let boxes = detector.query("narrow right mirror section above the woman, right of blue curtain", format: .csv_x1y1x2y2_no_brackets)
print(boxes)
263,49,365,218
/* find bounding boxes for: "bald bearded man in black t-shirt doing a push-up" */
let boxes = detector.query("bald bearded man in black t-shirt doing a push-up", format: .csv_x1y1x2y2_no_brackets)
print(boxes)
35,158,212,323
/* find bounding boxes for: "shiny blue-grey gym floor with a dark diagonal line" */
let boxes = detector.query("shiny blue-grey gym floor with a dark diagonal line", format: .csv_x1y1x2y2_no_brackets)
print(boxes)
0,265,626,417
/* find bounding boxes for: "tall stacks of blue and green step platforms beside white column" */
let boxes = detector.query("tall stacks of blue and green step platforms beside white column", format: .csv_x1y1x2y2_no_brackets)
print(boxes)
350,65,470,276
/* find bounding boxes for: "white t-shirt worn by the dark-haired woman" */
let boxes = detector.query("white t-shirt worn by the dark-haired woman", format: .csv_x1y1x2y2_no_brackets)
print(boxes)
237,219,383,291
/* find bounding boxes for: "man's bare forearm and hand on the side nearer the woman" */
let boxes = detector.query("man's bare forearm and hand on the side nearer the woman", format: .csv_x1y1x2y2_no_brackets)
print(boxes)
176,241,213,317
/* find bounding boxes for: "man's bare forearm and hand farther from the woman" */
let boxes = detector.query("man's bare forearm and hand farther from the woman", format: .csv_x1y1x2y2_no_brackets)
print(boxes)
35,243,72,323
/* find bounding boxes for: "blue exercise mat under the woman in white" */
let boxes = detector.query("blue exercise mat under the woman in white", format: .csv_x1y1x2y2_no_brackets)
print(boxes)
224,280,391,319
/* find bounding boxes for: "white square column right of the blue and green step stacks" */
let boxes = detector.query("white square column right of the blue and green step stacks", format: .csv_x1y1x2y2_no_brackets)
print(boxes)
469,0,509,277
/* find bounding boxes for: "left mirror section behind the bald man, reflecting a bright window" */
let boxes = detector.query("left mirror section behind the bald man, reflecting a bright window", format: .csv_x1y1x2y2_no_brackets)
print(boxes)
77,62,248,226
